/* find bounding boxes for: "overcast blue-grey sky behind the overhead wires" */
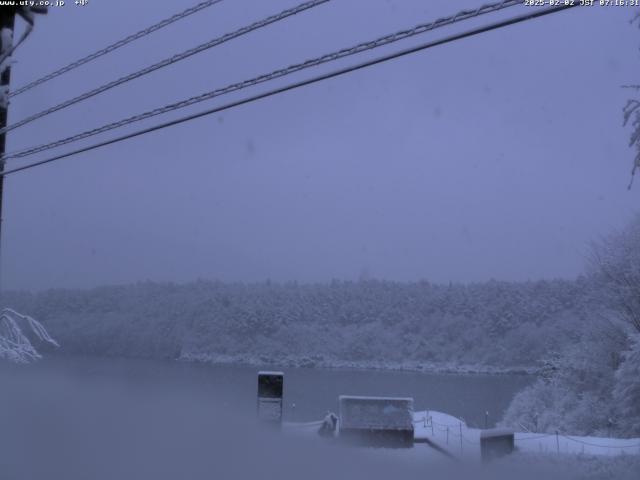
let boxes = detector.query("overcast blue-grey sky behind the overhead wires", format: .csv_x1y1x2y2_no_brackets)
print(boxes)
2,0,640,289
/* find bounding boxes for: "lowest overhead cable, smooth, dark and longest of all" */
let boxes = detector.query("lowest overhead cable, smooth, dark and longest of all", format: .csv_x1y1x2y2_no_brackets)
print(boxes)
2,4,578,176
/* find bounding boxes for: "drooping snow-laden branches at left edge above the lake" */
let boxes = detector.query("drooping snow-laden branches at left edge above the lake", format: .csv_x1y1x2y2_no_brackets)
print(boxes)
0,308,59,363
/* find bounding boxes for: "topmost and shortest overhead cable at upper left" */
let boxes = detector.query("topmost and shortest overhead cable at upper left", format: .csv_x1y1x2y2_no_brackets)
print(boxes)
9,0,222,97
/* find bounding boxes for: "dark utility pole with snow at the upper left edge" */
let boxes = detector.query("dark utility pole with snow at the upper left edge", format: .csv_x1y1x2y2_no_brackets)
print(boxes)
0,7,16,294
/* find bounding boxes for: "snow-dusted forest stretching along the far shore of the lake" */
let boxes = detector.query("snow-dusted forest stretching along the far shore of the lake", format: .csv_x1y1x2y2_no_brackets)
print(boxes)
2,277,609,371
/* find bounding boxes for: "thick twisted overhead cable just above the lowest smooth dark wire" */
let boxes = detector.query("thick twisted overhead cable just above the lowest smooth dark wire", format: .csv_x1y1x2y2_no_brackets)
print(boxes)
4,0,522,159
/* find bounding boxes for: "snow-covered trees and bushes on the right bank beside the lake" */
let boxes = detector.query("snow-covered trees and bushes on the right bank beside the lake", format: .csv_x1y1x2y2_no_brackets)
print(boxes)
504,215,640,436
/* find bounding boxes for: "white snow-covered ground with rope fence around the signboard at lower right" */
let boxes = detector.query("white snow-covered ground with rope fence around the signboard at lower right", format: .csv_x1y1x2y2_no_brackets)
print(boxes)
284,411,640,480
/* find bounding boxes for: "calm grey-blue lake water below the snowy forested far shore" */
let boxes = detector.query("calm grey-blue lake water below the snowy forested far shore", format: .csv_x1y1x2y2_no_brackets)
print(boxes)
0,356,532,427
